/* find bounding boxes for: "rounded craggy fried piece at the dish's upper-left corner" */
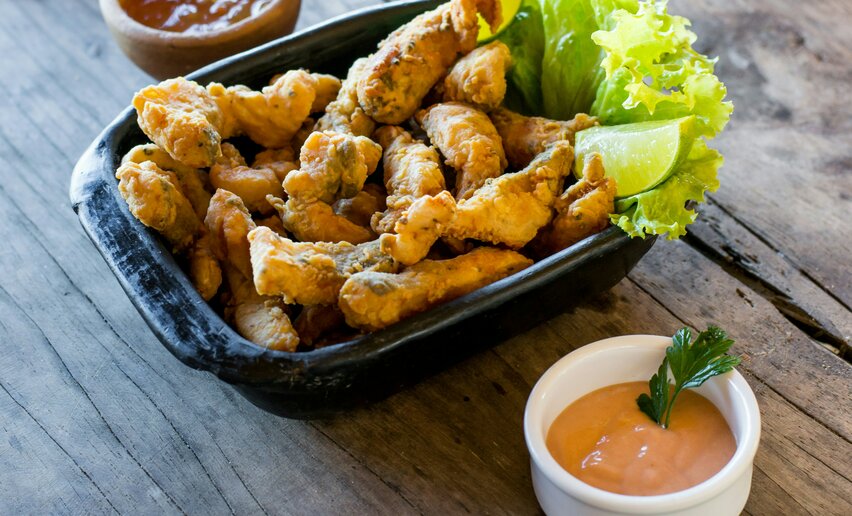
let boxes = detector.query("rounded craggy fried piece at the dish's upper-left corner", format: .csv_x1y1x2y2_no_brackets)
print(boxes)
133,77,225,168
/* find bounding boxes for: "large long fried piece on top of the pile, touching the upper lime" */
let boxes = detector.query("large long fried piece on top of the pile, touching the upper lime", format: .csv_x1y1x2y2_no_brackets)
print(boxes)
358,0,502,124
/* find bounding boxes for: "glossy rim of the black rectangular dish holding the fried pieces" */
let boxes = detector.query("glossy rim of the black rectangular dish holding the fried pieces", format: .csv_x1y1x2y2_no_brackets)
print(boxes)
70,1,652,385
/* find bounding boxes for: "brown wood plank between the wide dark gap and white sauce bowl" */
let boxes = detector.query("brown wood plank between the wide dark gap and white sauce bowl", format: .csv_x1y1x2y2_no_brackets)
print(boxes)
630,241,852,441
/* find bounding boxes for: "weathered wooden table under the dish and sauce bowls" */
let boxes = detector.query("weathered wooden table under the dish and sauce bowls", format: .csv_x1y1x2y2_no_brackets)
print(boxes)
0,0,852,515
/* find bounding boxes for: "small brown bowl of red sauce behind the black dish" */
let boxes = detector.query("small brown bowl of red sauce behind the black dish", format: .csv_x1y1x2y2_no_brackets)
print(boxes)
99,0,302,79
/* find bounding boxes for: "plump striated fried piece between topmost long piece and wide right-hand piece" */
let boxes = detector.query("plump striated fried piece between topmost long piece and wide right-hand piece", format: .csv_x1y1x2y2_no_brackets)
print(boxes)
417,102,507,199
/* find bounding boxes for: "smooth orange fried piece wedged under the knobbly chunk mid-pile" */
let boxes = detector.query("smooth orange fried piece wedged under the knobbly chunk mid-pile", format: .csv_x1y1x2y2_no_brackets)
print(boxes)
267,196,376,244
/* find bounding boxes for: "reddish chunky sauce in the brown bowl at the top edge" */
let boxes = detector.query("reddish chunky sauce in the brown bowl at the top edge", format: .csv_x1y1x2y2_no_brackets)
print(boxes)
119,0,272,33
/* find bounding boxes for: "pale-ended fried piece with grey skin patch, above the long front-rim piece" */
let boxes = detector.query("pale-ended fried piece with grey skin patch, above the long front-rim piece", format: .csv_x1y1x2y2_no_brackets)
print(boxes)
248,227,395,305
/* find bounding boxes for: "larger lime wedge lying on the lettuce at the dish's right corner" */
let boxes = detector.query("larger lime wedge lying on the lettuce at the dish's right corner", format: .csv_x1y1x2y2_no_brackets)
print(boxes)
574,116,695,197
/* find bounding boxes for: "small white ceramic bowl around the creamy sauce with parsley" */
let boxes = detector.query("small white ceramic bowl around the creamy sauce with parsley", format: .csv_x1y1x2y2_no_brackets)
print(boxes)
524,335,760,516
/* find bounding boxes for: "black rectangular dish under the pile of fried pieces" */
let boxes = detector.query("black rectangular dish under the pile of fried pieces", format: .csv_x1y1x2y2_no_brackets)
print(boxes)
70,1,654,418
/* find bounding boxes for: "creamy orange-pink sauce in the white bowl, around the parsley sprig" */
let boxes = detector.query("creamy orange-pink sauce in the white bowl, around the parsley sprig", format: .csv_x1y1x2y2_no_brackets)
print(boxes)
547,382,737,496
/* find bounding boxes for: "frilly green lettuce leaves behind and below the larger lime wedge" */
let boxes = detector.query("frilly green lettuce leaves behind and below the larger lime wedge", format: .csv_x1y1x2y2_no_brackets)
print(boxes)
499,0,733,239
